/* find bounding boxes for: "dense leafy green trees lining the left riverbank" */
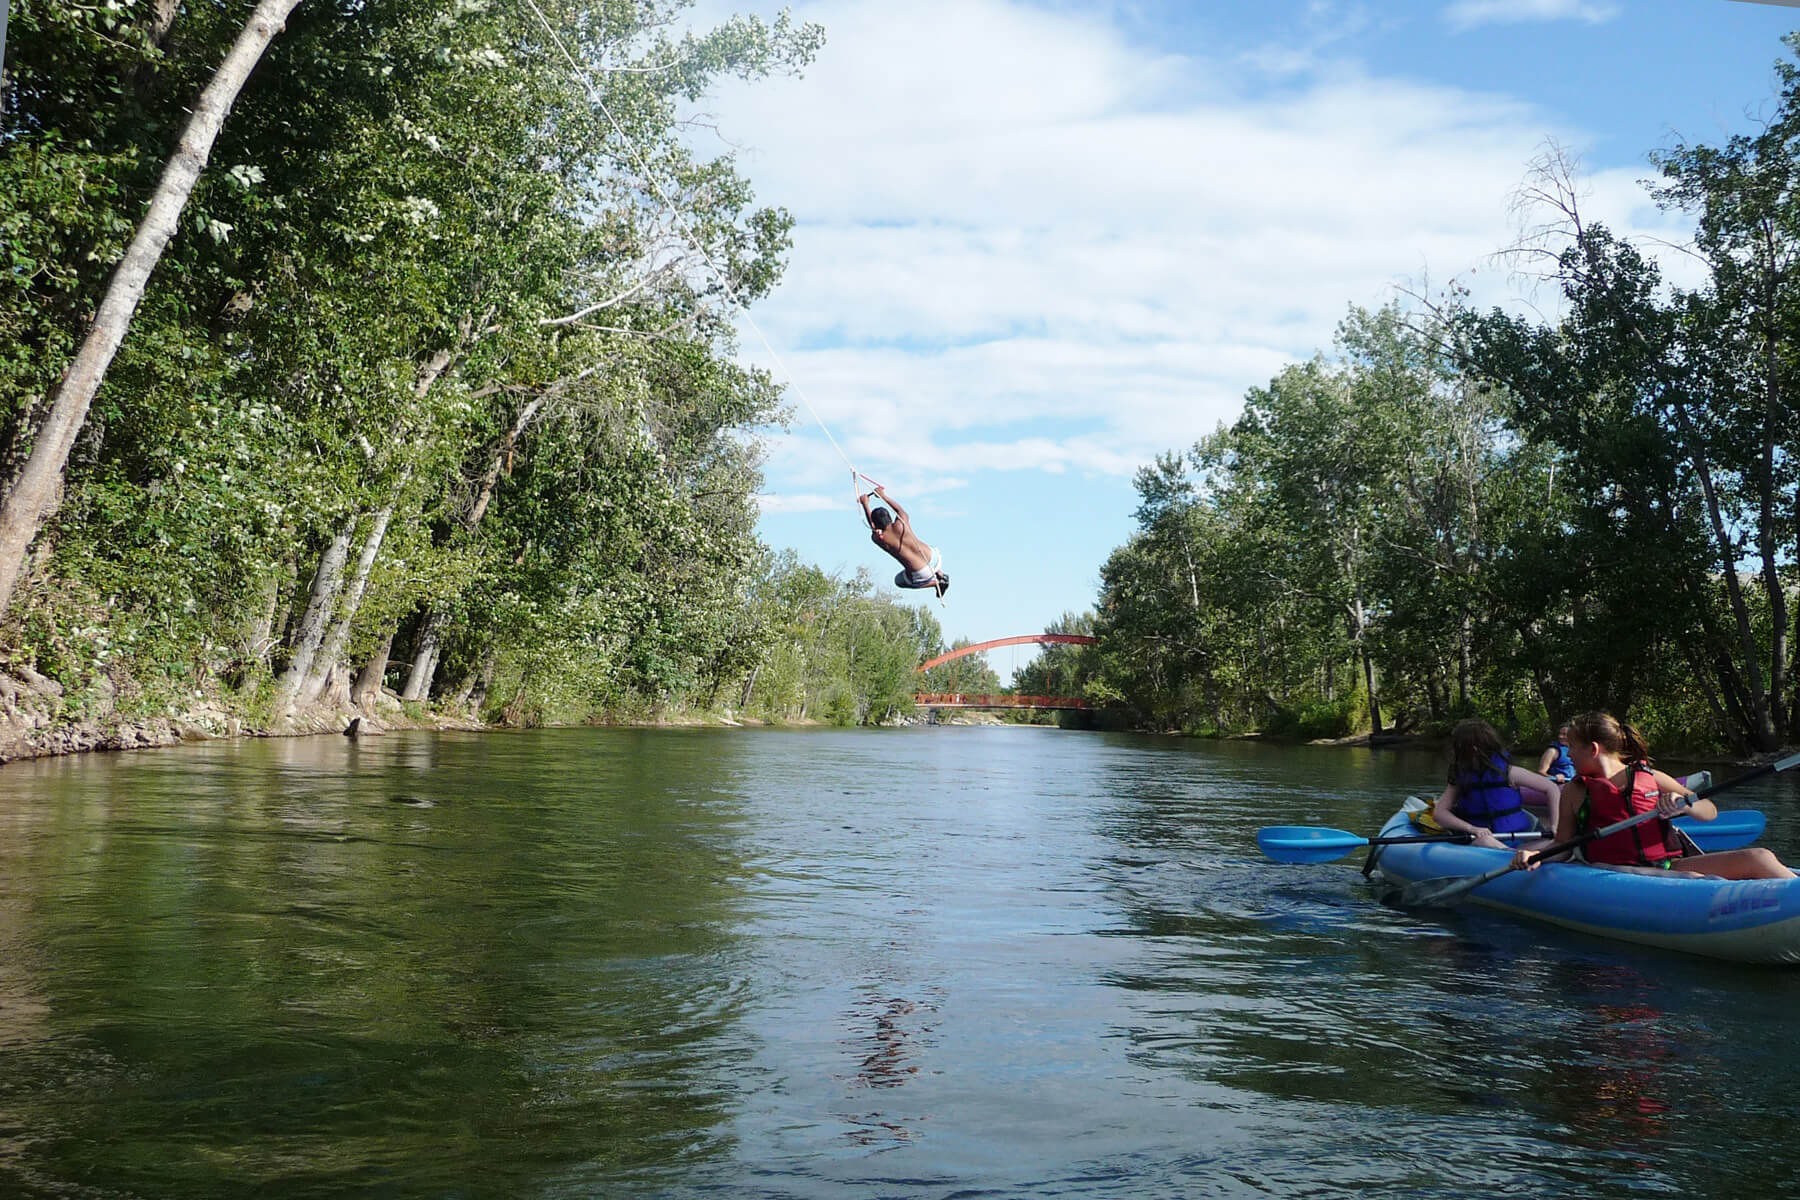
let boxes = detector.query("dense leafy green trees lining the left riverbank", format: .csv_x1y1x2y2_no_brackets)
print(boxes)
0,0,972,723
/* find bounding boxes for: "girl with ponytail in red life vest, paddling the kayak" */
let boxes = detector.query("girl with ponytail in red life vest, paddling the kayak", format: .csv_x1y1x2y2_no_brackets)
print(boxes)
1519,712,1795,880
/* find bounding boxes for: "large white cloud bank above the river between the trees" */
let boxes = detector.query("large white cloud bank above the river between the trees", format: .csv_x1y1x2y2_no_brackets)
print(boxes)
694,0,1660,511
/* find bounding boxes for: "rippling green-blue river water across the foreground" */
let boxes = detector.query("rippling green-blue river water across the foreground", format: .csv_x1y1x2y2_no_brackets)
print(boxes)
0,727,1800,1198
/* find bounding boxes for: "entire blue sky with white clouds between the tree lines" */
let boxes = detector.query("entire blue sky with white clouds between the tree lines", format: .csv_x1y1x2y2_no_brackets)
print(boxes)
684,0,1800,676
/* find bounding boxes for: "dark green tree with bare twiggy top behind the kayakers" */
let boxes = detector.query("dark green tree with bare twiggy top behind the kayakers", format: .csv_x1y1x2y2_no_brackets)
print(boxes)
1463,147,1782,748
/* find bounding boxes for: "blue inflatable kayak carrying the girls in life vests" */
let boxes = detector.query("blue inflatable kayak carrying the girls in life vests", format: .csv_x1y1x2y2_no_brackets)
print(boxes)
1372,810,1800,963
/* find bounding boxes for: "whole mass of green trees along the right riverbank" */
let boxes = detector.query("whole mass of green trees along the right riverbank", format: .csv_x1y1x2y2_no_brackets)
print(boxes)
1076,38,1800,750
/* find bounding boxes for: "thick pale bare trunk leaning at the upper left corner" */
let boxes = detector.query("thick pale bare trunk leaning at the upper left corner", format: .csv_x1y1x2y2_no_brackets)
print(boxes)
0,0,301,613
